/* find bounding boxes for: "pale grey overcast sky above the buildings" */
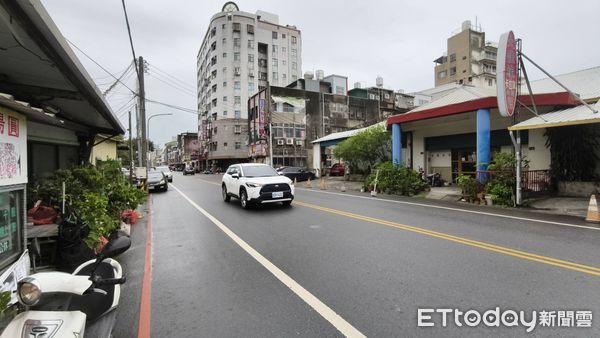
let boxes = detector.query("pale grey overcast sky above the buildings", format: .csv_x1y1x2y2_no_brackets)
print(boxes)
41,0,600,144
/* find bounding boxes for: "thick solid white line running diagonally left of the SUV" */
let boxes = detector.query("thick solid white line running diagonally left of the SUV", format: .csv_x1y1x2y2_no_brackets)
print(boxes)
171,184,366,337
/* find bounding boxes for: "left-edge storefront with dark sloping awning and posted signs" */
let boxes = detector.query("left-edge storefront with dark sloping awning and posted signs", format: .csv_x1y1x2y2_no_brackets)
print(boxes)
0,0,124,312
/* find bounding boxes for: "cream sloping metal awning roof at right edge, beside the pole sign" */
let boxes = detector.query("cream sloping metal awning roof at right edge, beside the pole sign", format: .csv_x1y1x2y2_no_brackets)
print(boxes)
508,101,600,130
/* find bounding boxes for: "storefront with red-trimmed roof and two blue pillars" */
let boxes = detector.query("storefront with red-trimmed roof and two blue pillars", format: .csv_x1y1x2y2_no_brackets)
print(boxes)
388,86,577,182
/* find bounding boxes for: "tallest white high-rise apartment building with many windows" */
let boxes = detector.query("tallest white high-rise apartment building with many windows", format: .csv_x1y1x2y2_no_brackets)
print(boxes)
197,2,302,169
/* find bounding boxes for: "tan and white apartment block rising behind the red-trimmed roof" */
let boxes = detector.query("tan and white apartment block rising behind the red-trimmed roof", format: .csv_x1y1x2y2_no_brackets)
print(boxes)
434,21,498,88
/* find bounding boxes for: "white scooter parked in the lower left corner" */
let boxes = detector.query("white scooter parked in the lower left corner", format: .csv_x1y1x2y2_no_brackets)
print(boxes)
0,237,131,338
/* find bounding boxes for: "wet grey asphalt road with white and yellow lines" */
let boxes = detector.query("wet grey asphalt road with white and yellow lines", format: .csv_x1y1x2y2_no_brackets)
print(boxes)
134,174,600,337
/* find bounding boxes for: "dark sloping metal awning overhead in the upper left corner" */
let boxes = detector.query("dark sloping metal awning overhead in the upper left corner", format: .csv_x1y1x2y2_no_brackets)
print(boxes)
0,0,125,135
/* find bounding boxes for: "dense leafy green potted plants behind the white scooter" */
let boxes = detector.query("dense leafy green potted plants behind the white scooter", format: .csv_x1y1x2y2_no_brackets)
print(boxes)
32,161,146,270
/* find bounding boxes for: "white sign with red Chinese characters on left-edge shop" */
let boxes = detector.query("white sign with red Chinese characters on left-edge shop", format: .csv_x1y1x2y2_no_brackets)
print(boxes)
0,107,27,186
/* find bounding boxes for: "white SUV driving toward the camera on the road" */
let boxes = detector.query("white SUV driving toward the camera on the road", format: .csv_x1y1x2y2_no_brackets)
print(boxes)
221,163,294,208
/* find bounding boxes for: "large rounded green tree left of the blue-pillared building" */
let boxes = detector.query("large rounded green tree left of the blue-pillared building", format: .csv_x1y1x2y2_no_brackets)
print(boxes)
333,125,392,173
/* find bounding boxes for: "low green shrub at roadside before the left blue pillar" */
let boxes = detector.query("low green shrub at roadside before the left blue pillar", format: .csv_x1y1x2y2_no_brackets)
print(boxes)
365,161,429,196
